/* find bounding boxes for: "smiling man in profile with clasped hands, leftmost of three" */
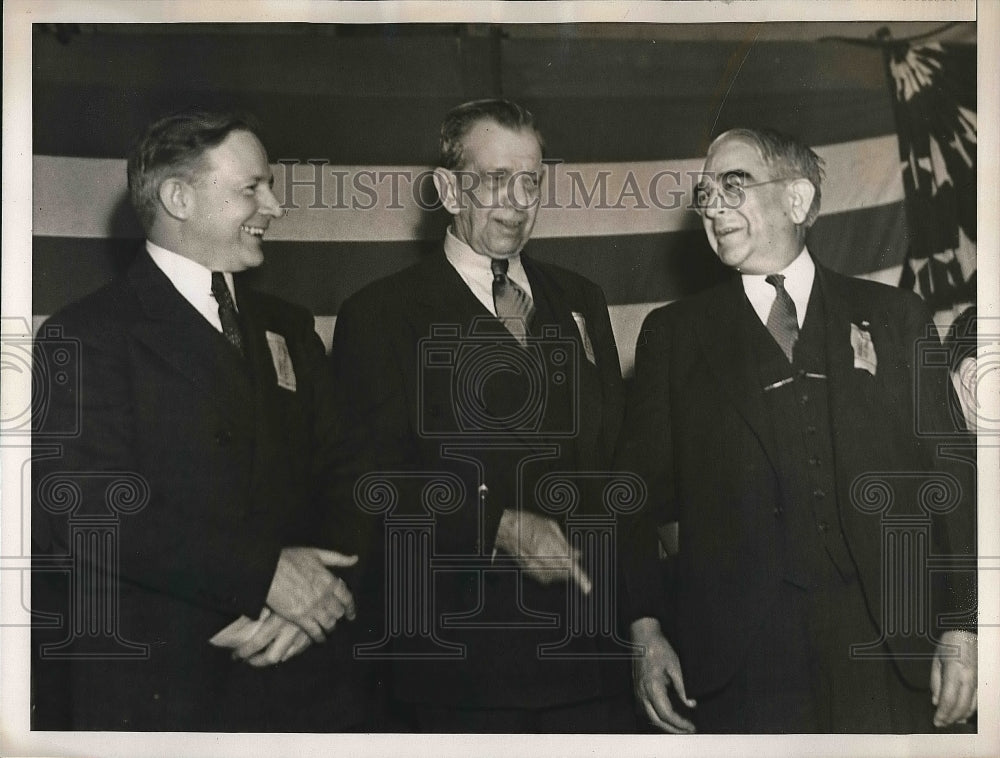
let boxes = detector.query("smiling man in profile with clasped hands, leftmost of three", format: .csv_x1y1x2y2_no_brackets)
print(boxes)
33,111,372,731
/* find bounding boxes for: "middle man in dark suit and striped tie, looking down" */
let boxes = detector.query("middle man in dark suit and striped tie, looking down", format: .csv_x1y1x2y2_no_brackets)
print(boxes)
332,100,632,732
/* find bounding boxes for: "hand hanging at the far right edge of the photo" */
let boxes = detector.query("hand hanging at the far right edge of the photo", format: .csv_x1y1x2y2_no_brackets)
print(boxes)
931,631,979,727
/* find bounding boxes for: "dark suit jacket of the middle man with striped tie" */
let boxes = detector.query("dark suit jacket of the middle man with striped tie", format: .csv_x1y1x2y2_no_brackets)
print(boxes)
332,253,627,708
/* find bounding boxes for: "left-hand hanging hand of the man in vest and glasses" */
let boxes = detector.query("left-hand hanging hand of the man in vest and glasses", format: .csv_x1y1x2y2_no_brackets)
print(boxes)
631,618,697,734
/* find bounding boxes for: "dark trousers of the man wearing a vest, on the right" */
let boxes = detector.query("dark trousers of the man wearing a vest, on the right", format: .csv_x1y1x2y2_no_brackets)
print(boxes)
692,574,934,734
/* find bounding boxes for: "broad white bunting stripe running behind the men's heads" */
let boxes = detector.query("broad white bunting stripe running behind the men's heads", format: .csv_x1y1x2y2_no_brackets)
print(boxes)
32,135,904,242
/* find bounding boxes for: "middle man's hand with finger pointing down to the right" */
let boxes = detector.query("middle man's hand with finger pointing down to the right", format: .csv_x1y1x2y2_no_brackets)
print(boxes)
496,509,591,595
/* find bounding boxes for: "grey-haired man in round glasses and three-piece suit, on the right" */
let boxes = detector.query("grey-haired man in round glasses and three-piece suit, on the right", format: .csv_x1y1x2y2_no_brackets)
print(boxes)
616,129,976,733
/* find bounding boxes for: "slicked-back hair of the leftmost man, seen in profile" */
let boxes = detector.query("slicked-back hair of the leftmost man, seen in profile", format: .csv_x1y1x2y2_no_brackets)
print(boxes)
128,109,260,232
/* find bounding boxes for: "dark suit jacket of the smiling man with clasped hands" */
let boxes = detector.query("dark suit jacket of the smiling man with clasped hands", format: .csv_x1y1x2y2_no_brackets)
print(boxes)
33,251,368,730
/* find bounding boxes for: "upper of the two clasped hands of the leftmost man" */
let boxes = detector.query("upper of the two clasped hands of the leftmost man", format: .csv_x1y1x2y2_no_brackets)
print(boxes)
267,547,358,642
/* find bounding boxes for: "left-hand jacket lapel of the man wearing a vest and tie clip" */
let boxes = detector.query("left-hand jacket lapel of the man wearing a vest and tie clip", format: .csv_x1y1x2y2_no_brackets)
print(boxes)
695,276,791,470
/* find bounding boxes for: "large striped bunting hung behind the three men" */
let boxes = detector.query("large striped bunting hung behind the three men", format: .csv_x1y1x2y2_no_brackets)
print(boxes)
32,25,968,373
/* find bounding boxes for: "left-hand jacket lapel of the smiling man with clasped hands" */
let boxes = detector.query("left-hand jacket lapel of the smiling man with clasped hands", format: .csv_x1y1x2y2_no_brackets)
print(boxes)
128,251,254,432
